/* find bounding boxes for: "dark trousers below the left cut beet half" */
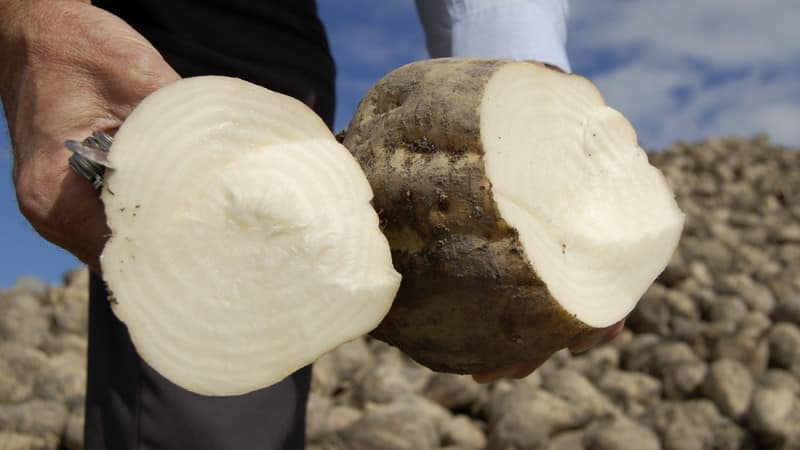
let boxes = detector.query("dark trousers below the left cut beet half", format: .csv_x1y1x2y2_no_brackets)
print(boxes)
85,274,311,450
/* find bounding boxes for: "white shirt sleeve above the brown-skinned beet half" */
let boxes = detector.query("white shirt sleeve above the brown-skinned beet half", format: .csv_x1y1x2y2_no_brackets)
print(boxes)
416,0,570,72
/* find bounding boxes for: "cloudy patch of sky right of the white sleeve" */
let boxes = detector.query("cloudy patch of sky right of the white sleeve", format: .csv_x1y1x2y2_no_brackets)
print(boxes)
570,0,800,148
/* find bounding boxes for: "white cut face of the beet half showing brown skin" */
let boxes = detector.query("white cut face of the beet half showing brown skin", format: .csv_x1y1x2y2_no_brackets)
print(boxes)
481,64,684,327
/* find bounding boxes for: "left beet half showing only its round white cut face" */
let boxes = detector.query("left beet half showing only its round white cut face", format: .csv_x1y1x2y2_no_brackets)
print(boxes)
101,77,400,395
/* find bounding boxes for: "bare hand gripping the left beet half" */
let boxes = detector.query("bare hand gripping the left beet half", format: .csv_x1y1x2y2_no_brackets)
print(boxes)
0,0,180,272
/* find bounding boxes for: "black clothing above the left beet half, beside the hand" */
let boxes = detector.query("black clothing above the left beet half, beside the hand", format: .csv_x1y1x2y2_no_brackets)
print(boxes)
93,0,335,126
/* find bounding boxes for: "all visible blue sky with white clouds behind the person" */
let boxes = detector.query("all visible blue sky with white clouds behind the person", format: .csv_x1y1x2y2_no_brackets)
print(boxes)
0,0,800,287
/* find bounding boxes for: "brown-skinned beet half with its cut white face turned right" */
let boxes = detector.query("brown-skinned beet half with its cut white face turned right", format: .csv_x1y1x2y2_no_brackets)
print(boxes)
344,59,684,373
